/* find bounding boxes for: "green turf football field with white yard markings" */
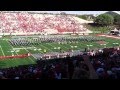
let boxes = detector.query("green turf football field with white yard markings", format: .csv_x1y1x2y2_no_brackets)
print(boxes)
0,34,120,68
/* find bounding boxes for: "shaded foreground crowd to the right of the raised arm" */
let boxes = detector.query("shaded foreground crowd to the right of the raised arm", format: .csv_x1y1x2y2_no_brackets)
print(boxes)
90,48,120,79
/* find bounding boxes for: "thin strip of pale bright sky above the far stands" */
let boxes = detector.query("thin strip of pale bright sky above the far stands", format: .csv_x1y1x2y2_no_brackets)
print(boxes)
35,11,107,15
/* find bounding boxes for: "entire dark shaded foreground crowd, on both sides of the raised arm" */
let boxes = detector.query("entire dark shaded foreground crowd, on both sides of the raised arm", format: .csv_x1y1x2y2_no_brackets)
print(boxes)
0,48,120,79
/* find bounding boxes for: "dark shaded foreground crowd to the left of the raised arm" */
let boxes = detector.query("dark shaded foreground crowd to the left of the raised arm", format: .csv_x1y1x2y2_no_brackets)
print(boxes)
0,56,89,79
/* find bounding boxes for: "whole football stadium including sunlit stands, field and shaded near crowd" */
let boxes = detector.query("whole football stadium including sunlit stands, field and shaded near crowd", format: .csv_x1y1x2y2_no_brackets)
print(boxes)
0,11,120,79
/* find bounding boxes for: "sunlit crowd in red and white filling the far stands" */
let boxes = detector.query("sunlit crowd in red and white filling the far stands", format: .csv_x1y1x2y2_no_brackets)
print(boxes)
0,12,86,33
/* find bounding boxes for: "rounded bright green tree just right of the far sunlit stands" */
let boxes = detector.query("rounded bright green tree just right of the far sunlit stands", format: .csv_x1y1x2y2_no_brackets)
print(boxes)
94,14,114,26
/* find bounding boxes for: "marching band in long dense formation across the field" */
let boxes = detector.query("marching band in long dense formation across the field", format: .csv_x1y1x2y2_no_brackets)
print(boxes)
9,36,103,46
